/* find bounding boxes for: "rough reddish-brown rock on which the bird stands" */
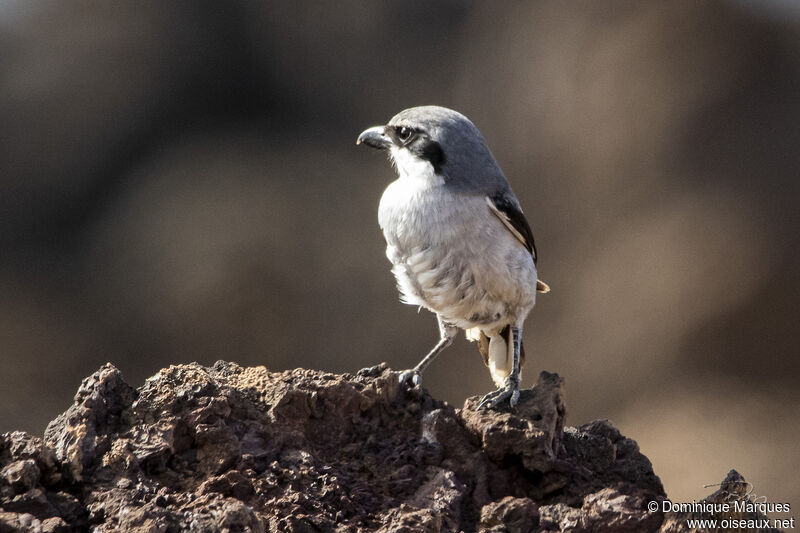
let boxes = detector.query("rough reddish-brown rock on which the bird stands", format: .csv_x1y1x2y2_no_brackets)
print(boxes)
0,361,780,532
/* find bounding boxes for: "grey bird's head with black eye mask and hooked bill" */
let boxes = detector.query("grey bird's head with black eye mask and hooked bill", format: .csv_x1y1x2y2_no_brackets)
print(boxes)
356,106,505,188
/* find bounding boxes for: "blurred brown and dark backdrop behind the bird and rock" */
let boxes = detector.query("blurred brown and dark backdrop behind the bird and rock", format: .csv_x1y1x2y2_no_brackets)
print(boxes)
0,0,800,504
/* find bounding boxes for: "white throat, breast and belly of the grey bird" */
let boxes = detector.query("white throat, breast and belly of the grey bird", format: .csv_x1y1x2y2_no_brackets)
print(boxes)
378,148,536,328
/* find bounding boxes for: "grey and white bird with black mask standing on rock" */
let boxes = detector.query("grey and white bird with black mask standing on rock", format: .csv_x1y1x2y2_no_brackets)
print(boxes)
356,106,550,409
